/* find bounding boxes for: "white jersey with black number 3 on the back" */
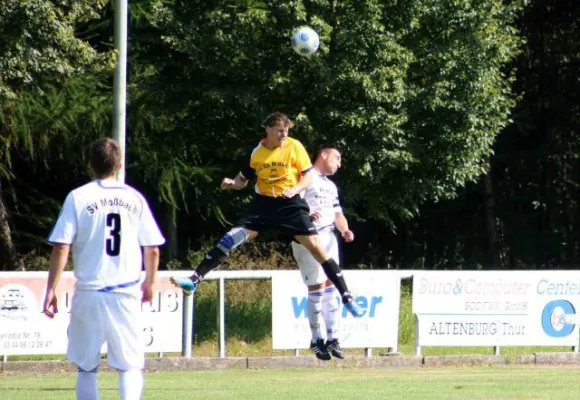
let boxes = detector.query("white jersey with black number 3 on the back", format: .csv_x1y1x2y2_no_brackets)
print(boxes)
48,179,165,294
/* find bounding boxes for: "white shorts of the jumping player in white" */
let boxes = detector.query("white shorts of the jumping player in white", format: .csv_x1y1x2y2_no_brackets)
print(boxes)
292,228,340,286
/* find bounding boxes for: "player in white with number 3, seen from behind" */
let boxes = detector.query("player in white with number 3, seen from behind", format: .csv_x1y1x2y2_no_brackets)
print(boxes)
44,138,165,400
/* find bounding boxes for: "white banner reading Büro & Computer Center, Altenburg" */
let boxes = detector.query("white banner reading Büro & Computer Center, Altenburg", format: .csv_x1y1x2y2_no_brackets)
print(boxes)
413,271,580,346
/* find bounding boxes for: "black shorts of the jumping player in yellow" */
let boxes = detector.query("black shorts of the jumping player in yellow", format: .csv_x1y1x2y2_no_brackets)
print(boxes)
236,194,317,236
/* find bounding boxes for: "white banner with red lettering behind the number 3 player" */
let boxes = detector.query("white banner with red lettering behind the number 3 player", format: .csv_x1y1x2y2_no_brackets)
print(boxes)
0,271,183,355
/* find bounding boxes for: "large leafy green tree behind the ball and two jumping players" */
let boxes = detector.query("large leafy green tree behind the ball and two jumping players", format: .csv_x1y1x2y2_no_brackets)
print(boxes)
150,0,522,221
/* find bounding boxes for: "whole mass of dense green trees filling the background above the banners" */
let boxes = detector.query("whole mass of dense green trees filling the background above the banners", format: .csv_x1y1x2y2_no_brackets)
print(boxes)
0,0,580,269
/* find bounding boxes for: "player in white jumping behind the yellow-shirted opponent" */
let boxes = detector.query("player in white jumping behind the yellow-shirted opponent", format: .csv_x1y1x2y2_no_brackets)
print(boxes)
292,146,354,361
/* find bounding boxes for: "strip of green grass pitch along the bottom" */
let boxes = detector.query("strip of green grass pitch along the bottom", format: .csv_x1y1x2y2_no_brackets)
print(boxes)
0,367,580,400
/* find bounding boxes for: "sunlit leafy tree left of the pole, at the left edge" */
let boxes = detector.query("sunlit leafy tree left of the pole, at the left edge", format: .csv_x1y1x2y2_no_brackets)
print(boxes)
0,0,112,269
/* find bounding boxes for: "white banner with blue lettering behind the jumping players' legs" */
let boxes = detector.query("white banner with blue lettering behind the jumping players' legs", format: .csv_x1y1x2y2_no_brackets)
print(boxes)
272,270,401,349
